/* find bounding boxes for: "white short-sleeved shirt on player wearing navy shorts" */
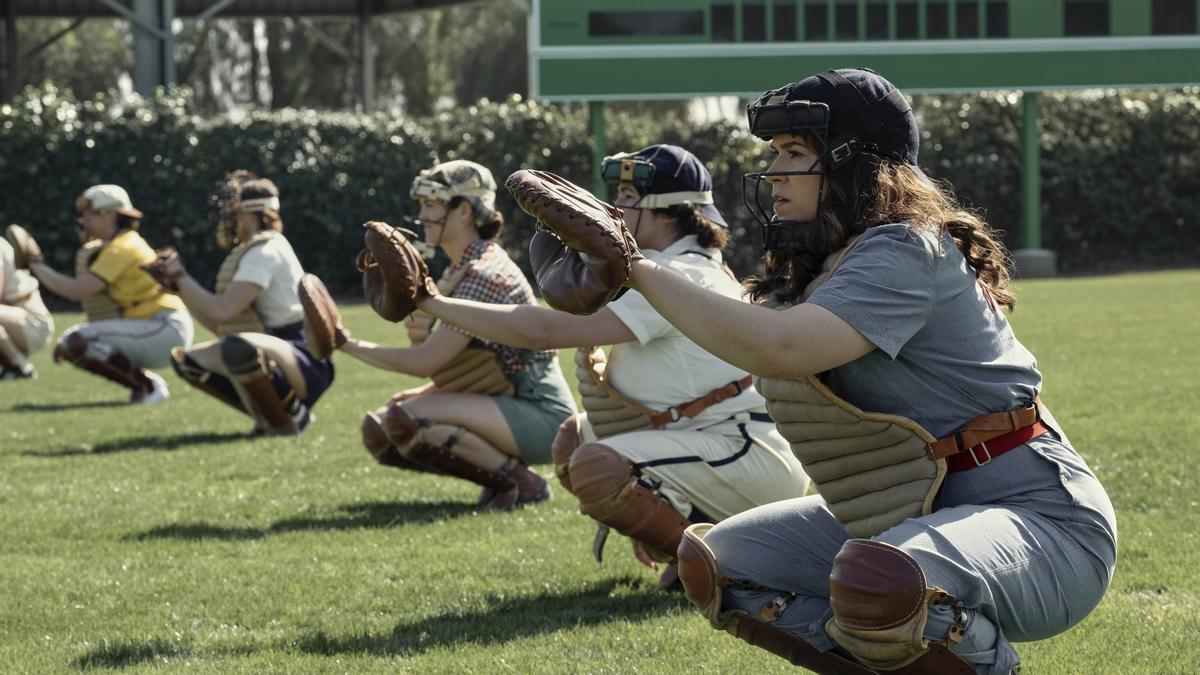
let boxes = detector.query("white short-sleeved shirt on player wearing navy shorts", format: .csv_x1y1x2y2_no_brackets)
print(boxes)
233,235,304,328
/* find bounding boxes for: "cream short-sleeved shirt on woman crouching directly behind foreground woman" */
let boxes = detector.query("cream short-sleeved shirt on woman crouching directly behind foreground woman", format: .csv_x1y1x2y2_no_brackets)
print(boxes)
608,234,767,429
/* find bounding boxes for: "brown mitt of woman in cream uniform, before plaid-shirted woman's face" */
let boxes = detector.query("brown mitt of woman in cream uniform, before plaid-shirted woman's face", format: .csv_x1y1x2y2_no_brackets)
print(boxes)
358,221,438,321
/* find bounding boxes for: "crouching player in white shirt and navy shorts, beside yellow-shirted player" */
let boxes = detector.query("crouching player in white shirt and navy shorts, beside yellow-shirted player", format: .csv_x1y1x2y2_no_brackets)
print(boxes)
150,171,334,436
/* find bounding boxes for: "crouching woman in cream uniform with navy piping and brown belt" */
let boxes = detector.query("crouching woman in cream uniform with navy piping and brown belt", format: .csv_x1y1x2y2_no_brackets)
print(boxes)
420,145,808,586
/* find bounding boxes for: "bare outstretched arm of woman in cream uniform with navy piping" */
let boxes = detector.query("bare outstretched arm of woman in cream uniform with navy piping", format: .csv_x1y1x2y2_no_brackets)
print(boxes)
420,295,636,350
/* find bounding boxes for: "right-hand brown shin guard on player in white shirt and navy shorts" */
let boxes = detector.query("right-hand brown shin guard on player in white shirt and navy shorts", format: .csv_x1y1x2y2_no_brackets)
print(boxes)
221,335,304,436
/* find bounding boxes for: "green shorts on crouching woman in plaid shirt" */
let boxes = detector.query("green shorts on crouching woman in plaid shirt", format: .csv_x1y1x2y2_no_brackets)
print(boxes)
493,357,576,464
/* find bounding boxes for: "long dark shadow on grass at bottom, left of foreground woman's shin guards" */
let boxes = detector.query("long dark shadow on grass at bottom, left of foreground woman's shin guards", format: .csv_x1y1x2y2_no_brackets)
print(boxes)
298,577,686,656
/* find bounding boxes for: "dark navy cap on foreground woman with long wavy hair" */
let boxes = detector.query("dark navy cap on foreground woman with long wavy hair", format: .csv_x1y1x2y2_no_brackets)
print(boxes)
746,68,920,167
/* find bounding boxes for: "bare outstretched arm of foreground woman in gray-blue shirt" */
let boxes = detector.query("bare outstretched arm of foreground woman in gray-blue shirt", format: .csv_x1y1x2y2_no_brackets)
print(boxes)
631,259,875,377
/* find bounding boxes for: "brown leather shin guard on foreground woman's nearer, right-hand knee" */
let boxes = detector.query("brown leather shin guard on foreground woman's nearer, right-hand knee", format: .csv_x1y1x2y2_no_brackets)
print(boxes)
826,539,974,675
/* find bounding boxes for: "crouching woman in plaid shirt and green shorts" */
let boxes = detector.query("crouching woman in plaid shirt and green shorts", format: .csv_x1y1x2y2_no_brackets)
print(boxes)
341,160,575,510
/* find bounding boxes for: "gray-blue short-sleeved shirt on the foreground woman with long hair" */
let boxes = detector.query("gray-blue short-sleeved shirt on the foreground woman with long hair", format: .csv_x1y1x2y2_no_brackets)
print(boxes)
808,225,1042,437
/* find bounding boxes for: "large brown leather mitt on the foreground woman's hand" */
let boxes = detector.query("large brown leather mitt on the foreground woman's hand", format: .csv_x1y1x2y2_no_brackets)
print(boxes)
504,169,642,315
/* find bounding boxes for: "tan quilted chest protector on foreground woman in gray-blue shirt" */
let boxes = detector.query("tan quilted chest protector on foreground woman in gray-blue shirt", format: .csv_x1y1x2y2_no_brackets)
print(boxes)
755,238,947,538
